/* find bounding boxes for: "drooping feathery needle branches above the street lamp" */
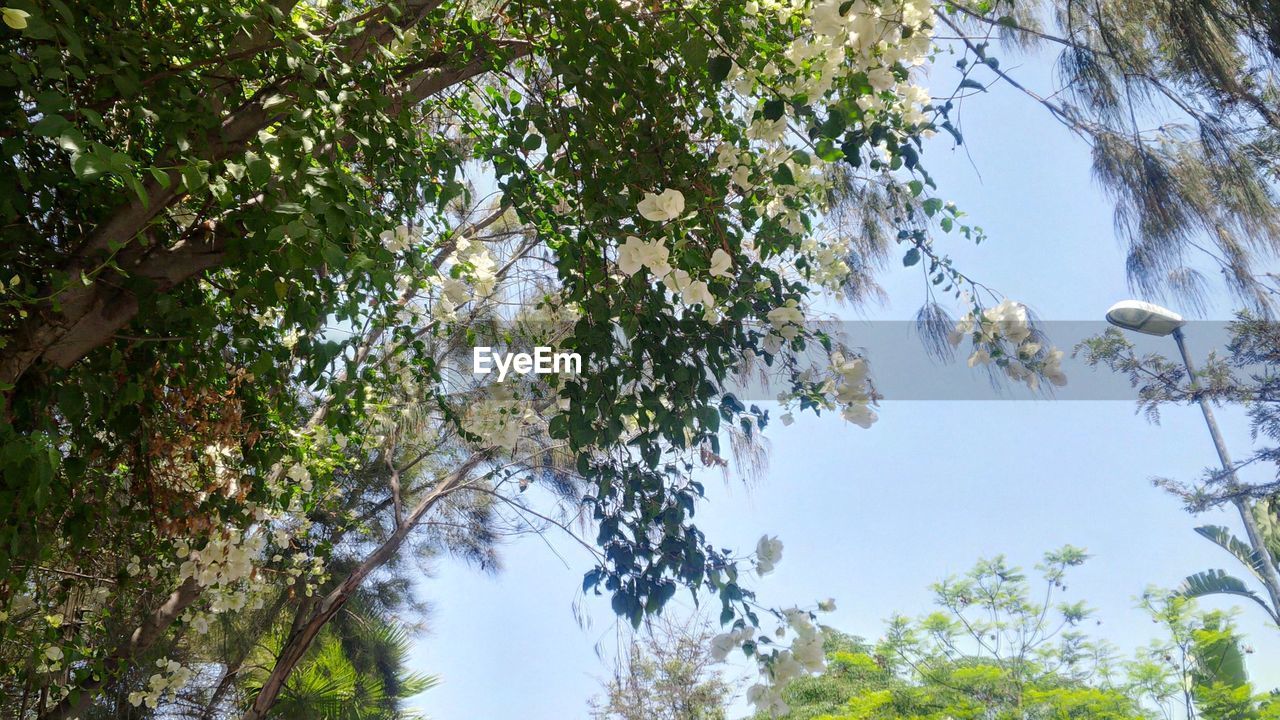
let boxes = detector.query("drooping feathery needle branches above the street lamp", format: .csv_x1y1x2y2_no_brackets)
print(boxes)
938,0,1280,314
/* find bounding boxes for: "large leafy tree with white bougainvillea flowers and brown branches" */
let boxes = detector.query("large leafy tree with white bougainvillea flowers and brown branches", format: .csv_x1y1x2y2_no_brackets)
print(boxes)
0,0,1041,720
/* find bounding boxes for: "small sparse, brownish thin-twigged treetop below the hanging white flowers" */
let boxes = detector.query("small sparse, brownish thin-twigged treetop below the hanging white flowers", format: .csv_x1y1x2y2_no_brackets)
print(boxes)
591,620,732,720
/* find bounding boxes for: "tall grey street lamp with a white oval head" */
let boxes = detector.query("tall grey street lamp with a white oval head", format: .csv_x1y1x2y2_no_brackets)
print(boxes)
1107,300,1280,614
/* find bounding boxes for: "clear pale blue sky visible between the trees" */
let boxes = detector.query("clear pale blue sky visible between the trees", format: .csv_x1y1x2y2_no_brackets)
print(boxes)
401,43,1280,720
